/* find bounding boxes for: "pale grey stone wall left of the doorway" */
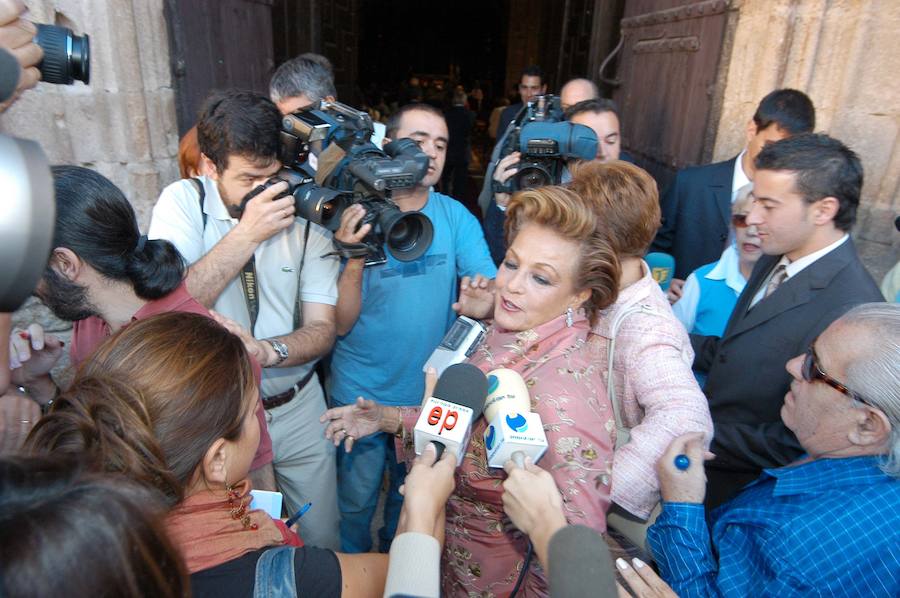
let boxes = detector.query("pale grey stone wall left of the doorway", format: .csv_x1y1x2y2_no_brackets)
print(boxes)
0,0,178,380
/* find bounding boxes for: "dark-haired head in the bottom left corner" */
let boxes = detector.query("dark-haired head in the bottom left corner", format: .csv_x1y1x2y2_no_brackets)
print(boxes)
0,456,190,598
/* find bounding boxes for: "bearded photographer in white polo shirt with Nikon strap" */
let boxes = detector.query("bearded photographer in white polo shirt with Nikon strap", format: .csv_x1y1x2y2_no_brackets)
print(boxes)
149,90,338,548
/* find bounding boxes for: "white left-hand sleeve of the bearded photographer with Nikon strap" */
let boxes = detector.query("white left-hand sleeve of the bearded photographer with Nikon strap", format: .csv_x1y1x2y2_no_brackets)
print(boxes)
147,179,206,265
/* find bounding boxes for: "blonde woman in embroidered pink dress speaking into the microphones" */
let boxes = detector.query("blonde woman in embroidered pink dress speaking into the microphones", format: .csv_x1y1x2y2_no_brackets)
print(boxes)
323,187,619,597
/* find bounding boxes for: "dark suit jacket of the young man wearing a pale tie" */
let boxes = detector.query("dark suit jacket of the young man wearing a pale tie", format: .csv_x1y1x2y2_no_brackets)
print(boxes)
691,239,884,506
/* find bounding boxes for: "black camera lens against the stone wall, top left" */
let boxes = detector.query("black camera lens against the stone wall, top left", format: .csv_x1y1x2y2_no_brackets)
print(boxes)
34,23,91,85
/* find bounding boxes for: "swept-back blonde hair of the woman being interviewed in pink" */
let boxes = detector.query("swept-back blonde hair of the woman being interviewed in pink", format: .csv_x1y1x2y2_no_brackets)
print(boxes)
505,187,620,324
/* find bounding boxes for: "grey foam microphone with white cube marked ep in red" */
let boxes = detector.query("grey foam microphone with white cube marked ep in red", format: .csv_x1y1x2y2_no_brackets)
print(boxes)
413,363,487,464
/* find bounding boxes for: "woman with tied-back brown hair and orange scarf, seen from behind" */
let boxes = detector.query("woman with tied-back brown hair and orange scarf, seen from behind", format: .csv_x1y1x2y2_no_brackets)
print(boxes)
26,313,450,597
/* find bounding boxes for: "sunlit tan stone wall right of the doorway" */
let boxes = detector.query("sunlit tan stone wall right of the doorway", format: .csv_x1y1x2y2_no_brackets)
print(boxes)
714,0,900,281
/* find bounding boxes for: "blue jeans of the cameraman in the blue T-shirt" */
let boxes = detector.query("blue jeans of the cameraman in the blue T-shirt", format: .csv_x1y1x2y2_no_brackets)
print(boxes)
337,432,406,553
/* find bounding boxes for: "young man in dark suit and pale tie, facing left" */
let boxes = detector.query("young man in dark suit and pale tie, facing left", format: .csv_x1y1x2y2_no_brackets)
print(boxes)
691,134,883,508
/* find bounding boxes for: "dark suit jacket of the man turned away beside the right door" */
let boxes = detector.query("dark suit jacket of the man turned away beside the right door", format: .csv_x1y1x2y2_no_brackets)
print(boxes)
651,157,737,280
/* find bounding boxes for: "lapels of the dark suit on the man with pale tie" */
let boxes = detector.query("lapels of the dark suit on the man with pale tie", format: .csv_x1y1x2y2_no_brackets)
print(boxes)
723,239,855,339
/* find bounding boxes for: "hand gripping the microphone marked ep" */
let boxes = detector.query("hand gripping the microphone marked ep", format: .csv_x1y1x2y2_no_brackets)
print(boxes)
397,442,456,544
